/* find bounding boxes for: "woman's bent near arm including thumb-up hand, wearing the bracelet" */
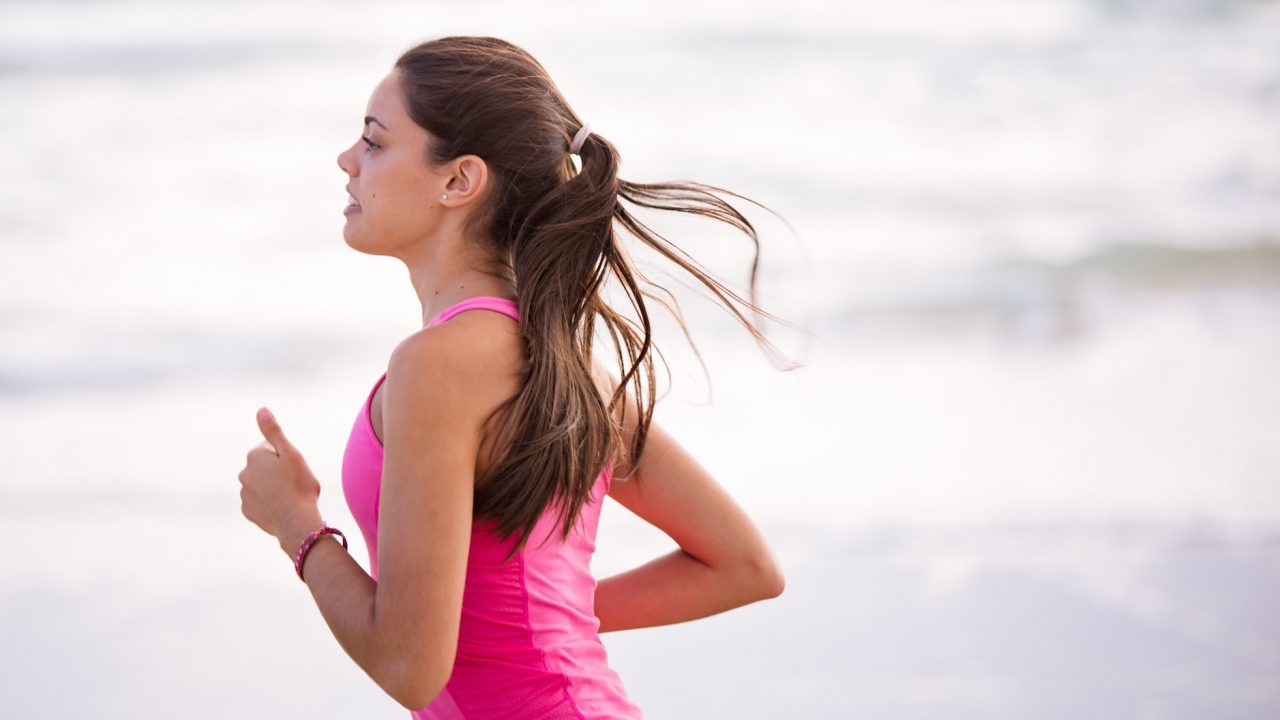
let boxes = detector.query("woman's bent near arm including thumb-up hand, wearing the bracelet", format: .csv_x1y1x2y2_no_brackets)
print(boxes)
241,323,500,710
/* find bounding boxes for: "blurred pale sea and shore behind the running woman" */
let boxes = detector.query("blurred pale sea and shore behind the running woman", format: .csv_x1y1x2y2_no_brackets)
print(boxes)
0,0,1280,720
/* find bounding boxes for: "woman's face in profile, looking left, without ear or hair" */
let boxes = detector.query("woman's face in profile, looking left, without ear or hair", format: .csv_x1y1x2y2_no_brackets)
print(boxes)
338,70,447,258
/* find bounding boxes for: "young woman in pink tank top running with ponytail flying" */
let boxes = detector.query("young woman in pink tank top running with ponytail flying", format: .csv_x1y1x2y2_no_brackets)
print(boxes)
239,37,783,719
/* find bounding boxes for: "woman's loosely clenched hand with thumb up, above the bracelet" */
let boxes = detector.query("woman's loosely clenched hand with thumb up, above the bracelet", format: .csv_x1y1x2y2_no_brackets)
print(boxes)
239,407,324,552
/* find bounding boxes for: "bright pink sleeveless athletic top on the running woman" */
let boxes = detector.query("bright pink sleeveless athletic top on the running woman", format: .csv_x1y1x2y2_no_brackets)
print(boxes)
342,296,643,720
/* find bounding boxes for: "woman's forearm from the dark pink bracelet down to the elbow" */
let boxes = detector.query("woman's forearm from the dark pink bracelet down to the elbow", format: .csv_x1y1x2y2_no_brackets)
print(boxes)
280,523,396,697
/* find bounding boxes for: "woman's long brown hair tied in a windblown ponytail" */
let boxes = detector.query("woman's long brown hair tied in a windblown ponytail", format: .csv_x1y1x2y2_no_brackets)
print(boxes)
394,36,777,552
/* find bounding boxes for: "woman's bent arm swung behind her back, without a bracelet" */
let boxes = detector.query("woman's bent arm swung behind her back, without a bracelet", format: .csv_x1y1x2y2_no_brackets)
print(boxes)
595,358,785,633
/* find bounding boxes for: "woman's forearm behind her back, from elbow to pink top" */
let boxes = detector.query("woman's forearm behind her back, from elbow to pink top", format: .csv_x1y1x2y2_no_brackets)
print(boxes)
595,550,781,633
